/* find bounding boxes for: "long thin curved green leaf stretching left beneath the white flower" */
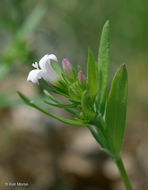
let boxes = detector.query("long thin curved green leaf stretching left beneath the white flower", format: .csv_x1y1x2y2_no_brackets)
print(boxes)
18,92,87,126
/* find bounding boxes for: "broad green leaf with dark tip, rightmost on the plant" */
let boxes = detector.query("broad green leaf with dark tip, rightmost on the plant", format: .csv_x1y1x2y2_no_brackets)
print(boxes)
105,65,128,154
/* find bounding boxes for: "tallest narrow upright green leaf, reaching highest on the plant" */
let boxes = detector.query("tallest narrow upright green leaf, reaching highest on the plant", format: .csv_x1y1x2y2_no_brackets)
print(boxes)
97,21,110,115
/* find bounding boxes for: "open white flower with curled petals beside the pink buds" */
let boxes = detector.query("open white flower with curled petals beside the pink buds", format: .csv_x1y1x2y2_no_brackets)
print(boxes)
27,54,59,84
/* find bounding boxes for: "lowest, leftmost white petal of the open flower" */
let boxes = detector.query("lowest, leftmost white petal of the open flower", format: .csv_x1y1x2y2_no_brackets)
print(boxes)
27,69,43,84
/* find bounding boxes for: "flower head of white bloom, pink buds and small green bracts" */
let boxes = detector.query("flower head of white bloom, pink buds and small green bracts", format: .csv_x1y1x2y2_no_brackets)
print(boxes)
27,54,96,122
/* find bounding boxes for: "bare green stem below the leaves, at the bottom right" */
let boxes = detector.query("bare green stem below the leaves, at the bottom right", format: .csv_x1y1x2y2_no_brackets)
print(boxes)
113,155,133,190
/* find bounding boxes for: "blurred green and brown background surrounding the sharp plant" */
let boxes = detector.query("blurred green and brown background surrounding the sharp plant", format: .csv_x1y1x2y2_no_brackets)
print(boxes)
0,0,148,190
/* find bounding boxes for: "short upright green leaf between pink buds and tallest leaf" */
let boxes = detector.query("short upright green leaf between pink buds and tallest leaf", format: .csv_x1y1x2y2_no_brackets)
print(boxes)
87,49,98,97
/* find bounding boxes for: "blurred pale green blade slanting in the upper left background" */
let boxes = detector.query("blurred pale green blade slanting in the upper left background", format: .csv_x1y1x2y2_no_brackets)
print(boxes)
18,3,47,39
